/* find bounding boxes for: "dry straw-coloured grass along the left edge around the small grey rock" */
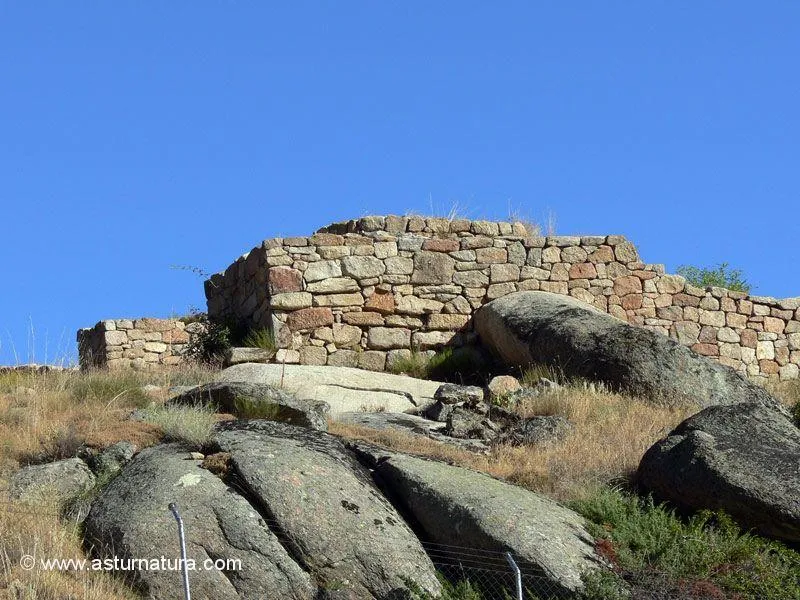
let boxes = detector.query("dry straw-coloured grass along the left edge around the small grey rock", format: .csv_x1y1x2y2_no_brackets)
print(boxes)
0,367,212,600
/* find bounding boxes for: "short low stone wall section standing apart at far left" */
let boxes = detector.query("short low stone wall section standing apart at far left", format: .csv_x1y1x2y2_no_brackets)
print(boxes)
78,319,198,370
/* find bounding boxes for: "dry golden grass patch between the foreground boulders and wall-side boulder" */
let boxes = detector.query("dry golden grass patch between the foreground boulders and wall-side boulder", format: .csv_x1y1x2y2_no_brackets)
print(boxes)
330,387,694,501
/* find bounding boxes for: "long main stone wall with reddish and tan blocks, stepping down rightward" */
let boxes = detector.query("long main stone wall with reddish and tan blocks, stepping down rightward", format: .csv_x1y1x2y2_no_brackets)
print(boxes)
208,216,800,379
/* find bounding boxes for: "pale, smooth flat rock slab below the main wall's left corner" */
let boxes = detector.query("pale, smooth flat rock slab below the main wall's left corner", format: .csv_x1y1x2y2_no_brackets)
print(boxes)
215,363,441,415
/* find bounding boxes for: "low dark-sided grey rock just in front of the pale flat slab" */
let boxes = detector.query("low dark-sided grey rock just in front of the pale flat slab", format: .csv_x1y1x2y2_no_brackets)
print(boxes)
170,381,329,431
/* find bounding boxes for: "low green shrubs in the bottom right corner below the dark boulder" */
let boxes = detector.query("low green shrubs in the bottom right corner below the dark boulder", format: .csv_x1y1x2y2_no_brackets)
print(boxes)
571,488,800,600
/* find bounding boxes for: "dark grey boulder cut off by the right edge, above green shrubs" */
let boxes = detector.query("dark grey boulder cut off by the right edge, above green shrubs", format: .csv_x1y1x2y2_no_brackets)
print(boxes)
638,404,800,542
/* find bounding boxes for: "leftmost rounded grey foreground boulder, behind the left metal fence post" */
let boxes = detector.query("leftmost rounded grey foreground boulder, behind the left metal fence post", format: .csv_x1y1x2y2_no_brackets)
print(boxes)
84,444,317,600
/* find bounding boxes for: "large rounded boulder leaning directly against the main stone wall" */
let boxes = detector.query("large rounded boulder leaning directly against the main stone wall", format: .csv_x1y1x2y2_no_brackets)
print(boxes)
474,292,782,410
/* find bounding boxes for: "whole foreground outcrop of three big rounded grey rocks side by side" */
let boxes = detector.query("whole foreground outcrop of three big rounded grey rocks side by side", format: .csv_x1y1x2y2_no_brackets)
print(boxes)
85,415,600,600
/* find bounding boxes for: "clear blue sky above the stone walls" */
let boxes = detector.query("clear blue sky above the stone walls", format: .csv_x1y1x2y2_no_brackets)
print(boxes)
0,0,800,364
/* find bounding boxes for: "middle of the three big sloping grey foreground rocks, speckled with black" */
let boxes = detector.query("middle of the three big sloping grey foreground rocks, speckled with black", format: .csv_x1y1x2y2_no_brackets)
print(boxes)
213,420,440,600
